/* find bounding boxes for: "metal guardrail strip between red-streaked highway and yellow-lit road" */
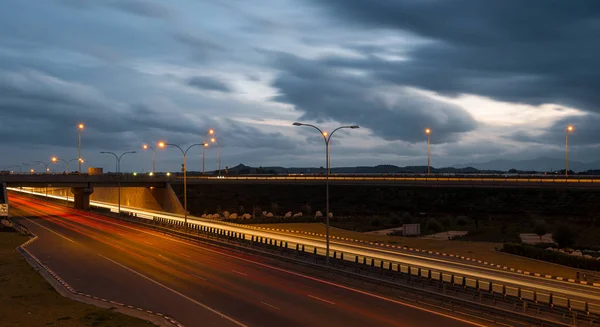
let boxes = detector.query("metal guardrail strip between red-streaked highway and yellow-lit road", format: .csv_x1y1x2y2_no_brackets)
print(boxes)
120,217,600,326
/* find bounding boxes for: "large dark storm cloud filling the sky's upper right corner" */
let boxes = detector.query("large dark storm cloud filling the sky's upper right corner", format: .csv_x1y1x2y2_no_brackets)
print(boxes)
315,0,600,112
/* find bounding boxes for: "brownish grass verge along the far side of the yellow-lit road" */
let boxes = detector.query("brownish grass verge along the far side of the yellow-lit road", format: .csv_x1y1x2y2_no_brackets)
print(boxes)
255,223,577,278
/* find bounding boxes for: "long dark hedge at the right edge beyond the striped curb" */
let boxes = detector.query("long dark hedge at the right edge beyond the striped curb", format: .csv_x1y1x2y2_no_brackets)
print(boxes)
502,243,600,271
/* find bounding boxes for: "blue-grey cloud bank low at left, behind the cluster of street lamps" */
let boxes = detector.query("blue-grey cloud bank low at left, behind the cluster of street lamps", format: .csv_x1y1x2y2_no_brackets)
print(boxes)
0,70,295,150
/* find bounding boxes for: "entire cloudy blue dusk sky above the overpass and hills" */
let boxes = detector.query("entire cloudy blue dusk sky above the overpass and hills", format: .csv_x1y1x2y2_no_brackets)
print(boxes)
0,0,600,172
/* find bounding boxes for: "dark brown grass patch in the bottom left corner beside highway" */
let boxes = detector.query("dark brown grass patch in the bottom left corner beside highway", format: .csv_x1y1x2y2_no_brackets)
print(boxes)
0,227,153,327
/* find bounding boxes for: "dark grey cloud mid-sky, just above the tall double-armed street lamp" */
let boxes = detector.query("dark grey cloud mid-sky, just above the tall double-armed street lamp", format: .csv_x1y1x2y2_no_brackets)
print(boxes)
272,54,477,142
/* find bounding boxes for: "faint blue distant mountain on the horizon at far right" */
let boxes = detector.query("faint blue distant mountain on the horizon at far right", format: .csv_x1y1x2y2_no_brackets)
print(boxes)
454,157,600,172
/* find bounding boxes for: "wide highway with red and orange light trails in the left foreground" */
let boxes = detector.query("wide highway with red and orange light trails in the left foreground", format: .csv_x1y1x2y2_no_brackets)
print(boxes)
10,193,472,326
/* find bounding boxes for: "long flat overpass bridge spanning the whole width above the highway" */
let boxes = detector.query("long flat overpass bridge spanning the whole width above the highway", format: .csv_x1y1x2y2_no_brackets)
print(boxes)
0,174,600,210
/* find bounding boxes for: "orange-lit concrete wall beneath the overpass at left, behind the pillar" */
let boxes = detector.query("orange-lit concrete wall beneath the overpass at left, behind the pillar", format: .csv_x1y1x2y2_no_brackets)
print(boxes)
23,185,184,214
